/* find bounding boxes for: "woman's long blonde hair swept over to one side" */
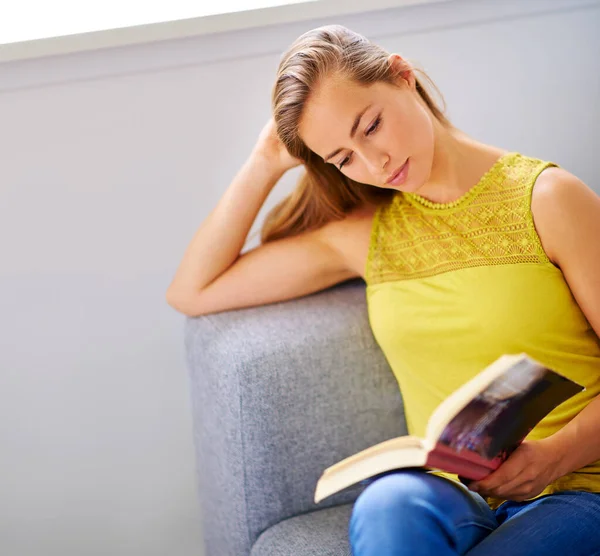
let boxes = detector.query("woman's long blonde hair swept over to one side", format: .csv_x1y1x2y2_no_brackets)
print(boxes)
261,25,451,243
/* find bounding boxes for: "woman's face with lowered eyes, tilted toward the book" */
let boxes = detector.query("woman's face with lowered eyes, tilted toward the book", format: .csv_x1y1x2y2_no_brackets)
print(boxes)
299,63,434,192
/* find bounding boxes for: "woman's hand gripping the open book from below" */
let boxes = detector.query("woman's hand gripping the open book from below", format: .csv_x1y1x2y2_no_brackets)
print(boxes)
469,437,561,502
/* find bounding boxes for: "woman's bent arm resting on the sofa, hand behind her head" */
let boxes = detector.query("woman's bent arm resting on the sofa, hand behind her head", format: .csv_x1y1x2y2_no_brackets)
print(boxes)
167,121,356,316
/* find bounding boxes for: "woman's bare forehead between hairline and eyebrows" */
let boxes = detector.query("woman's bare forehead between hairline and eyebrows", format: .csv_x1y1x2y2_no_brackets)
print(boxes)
298,77,381,157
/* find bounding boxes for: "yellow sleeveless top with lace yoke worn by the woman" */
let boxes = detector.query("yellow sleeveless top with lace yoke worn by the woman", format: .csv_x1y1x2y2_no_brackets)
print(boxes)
365,152,600,508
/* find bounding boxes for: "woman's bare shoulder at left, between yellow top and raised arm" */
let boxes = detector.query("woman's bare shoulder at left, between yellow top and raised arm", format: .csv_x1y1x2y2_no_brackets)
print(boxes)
321,205,377,278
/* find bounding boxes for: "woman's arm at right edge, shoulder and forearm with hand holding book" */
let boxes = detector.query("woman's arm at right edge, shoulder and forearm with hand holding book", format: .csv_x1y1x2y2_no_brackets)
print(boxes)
469,168,600,500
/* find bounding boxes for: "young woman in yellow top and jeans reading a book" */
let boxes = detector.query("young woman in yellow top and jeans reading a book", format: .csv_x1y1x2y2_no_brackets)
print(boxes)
167,26,600,556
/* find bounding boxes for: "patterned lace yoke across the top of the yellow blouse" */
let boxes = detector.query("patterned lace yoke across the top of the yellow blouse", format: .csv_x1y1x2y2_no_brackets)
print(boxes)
365,152,558,285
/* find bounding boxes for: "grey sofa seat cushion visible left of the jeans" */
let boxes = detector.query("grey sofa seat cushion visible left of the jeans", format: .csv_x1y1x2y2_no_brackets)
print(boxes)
250,504,353,556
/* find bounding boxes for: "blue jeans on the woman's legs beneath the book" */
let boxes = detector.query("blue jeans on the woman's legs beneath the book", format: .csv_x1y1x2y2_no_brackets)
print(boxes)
350,469,600,556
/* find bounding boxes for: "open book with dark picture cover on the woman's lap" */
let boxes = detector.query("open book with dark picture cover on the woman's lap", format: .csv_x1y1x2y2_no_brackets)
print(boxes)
315,354,584,502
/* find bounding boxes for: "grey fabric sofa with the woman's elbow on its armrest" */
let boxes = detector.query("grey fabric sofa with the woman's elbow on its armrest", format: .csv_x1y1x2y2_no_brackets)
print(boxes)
185,280,406,556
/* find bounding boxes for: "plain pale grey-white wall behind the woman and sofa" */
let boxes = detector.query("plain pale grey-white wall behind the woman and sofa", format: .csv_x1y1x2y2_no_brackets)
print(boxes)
0,0,600,556
